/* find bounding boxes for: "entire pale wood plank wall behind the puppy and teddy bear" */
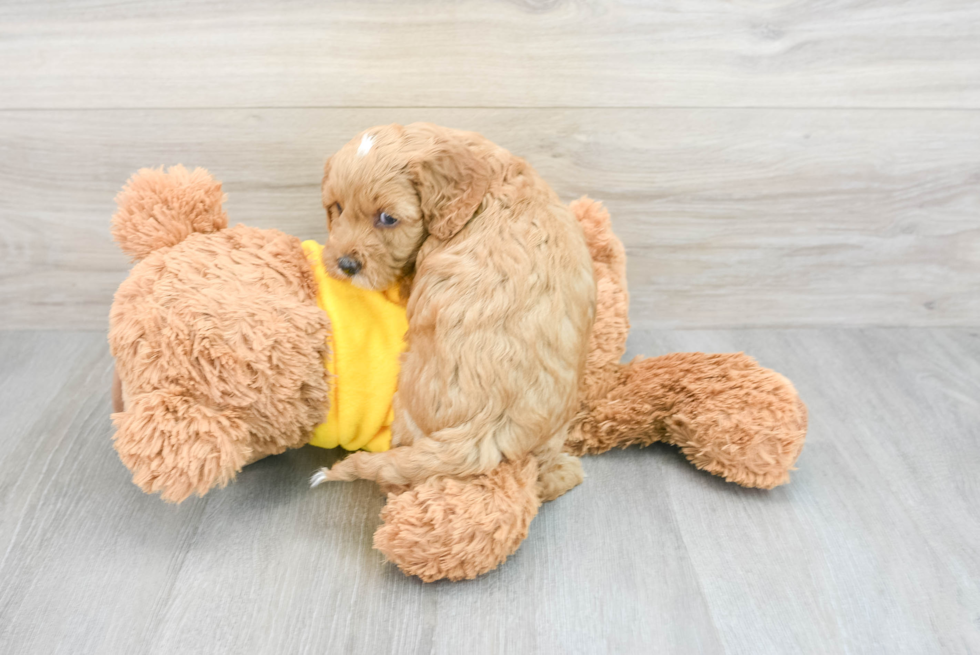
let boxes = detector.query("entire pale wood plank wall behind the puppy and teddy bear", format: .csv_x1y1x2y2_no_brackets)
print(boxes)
0,0,980,329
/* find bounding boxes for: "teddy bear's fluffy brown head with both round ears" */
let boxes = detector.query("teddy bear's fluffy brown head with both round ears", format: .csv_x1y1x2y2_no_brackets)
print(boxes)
109,166,329,501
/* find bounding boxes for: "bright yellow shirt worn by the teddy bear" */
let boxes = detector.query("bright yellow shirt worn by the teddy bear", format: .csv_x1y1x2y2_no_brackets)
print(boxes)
303,241,408,452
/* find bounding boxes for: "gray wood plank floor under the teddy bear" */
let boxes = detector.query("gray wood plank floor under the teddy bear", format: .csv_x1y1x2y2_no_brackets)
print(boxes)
0,329,980,654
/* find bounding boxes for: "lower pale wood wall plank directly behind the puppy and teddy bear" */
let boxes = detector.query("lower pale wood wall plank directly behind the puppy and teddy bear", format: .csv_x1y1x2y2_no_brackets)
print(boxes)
0,108,980,328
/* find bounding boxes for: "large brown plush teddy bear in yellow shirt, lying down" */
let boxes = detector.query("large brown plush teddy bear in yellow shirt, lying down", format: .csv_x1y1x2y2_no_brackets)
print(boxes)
109,166,807,581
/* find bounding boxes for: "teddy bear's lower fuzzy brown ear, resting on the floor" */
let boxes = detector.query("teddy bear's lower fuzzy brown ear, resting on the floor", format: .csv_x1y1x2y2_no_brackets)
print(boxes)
112,388,253,502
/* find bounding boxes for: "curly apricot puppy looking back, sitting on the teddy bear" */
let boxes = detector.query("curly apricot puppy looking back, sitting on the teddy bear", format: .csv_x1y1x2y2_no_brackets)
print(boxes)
316,123,596,501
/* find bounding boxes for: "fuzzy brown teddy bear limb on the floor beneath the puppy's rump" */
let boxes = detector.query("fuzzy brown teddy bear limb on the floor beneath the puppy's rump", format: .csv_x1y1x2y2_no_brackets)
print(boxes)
374,457,539,582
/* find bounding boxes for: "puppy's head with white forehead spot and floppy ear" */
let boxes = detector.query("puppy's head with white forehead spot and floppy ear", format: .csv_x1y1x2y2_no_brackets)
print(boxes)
321,123,490,289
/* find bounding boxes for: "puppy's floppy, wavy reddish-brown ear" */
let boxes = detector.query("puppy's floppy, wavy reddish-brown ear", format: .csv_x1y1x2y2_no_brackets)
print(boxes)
411,134,490,241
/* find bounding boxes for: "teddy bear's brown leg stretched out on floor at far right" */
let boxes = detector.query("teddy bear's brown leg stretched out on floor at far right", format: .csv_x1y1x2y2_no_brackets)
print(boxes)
566,353,807,489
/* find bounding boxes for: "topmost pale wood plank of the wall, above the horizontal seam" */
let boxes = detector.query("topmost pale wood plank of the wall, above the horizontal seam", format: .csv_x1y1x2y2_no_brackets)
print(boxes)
0,0,980,108
